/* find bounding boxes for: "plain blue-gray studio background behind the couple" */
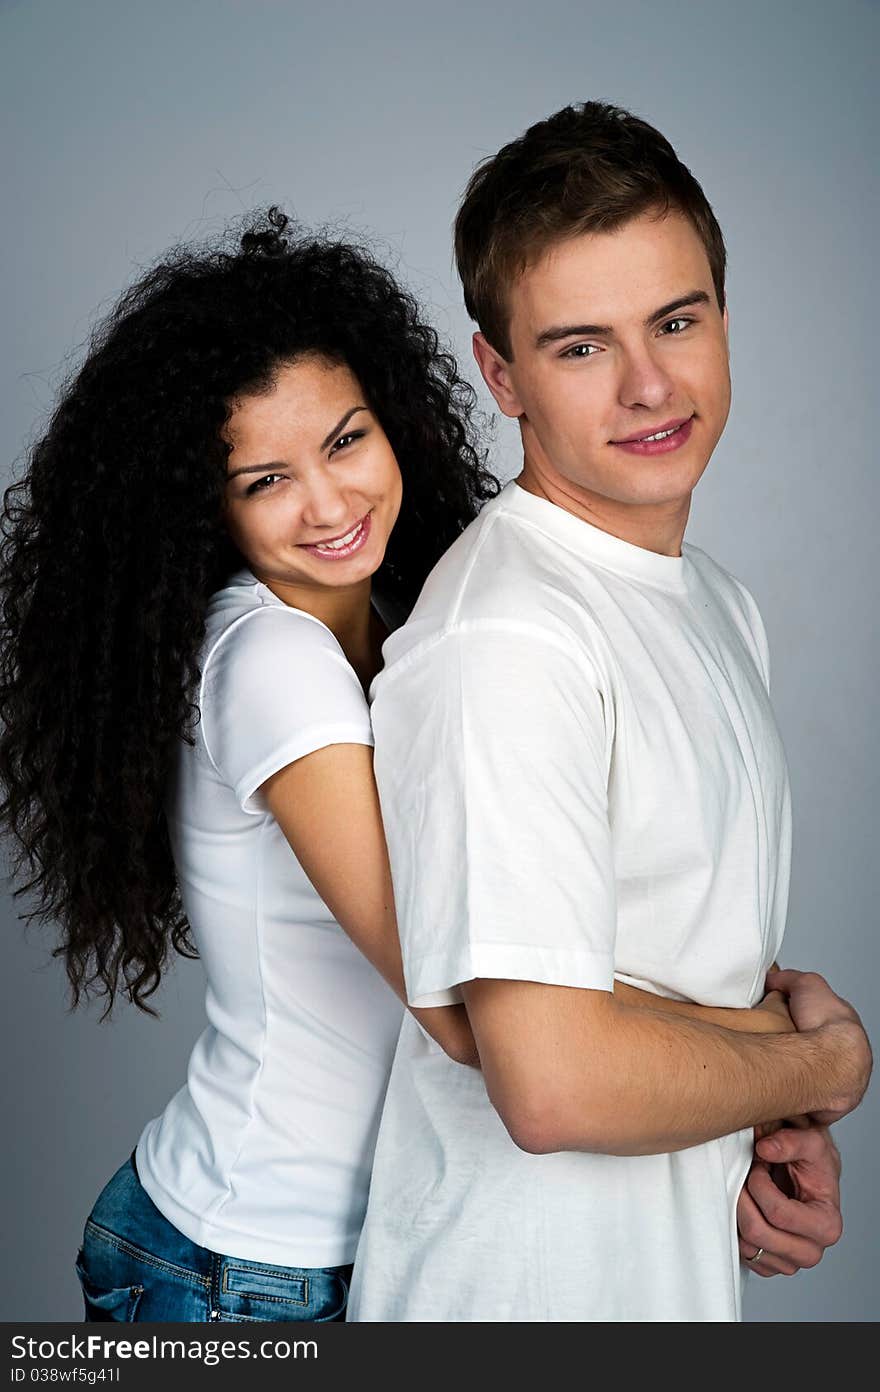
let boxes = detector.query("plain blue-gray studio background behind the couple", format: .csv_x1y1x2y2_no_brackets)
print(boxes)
0,0,880,1321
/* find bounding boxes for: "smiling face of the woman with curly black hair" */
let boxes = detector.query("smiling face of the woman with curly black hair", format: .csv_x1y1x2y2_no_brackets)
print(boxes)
226,356,402,590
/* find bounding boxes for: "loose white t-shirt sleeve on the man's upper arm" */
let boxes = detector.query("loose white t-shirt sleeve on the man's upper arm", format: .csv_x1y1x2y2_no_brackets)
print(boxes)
372,625,617,1005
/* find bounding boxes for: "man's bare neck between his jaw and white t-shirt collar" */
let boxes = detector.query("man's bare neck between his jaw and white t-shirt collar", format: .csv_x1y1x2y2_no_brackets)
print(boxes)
517,457,691,555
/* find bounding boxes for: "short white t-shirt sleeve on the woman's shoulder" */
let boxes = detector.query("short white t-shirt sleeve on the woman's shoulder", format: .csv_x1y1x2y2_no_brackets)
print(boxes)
199,608,373,814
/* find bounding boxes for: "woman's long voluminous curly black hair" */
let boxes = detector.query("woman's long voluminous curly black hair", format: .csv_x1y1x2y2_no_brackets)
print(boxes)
0,209,498,1013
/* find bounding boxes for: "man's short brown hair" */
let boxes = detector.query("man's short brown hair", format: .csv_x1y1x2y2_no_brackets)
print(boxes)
455,102,727,362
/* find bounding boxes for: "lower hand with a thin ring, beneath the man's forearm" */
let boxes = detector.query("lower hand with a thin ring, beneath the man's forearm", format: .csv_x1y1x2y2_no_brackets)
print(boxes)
737,1118,844,1276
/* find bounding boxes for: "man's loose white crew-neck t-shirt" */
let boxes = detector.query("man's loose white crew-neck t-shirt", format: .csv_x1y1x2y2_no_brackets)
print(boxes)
348,483,791,1321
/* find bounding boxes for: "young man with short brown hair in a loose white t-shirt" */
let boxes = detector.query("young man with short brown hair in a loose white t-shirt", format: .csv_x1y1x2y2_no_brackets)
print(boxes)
349,103,870,1321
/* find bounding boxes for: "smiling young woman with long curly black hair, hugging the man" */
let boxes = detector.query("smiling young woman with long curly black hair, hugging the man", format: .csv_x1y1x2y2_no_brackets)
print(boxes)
0,210,497,1321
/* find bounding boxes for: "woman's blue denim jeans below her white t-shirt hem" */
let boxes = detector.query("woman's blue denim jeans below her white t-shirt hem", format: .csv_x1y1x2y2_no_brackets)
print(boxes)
77,1157,351,1324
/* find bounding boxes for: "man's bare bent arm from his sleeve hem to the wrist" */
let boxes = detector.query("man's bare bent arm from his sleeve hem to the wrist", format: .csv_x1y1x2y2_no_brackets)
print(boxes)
464,981,858,1155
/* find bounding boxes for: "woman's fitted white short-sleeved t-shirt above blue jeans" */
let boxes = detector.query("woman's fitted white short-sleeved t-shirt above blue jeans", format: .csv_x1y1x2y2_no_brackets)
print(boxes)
136,571,402,1267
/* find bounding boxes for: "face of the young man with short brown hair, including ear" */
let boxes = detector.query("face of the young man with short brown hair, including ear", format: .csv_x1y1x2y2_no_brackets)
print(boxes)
475,213,730,521
